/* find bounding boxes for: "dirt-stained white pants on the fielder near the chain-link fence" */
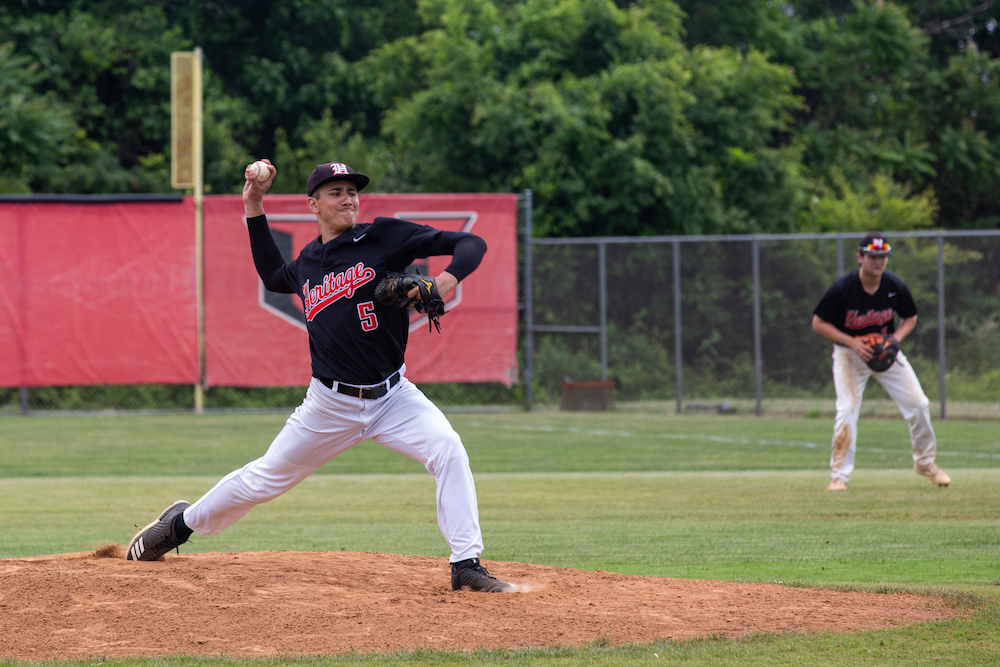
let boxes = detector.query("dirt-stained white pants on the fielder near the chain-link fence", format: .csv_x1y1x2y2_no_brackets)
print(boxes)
830,345,937,482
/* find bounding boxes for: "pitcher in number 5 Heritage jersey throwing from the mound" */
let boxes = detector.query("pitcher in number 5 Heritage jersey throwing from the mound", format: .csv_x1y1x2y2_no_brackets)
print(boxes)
127,161,513,592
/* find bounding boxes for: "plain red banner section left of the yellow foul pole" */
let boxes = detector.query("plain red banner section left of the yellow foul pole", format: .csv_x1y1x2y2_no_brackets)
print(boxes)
0,199,198,387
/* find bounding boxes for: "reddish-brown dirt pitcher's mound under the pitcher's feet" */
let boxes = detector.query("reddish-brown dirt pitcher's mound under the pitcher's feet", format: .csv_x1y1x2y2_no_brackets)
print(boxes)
0,545,955,660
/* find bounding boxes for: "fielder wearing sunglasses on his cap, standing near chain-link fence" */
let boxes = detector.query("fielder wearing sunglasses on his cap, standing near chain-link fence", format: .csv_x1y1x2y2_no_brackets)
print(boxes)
812,232,951,491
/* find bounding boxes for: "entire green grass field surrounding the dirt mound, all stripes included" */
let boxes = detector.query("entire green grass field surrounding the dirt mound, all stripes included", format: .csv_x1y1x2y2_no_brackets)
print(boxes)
0,412,1000,667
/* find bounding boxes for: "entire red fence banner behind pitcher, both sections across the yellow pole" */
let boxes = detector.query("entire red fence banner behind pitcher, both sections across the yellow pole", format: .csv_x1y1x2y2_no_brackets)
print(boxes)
0,194,517,387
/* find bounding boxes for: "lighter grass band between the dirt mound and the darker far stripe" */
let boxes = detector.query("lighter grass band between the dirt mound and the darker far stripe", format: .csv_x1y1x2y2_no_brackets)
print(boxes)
0,469,1000,587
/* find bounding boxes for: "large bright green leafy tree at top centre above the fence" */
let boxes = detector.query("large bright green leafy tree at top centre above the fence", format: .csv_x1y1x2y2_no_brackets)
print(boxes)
365,0,797,235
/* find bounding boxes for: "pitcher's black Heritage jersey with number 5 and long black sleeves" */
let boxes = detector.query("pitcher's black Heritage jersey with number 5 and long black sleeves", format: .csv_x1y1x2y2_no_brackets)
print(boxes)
247,215,486,385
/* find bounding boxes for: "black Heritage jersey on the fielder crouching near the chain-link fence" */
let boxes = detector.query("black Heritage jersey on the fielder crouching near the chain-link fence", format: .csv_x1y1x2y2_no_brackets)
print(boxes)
813,271,917,336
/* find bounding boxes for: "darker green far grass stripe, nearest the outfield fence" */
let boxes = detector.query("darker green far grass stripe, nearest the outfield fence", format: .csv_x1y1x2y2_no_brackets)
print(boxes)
0,413,1000,478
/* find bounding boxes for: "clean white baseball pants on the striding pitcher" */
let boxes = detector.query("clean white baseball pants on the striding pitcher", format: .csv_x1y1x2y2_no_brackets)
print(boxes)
184,377,483,563
